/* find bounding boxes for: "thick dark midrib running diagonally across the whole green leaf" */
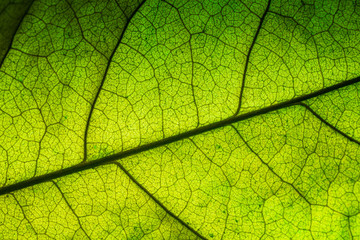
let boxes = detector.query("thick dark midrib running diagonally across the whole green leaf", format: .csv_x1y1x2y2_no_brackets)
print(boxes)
0,76,360,196
